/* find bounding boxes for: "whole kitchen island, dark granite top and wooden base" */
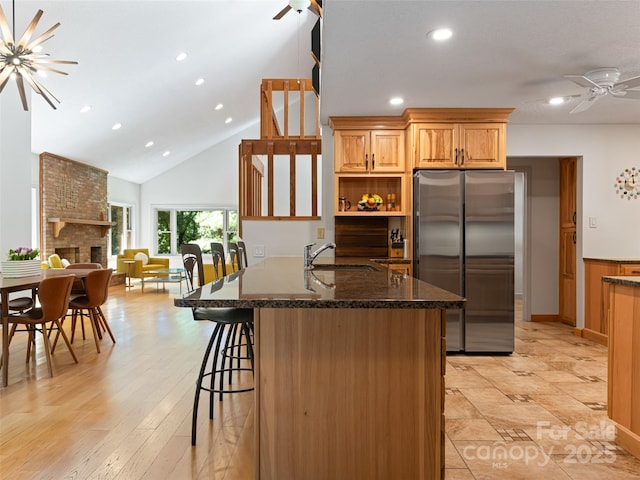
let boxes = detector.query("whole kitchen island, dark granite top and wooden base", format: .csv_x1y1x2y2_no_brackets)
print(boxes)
174,257,464,480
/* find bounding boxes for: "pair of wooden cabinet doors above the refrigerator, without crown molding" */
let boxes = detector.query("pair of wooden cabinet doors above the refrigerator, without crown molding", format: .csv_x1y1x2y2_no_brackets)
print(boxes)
412,123,507,169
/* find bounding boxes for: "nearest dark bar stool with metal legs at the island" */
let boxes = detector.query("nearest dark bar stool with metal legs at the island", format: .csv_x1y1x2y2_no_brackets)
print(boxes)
180,244,254,445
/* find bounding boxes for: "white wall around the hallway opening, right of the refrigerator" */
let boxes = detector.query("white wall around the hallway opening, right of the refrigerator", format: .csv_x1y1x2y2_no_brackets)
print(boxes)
507,124,640,328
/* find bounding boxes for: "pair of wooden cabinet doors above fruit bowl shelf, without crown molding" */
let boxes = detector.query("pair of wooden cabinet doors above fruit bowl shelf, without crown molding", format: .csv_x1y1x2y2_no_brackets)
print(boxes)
334,130,405,173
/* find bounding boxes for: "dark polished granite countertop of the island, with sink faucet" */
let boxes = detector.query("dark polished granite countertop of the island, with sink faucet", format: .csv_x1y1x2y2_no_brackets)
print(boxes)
174,257,465,309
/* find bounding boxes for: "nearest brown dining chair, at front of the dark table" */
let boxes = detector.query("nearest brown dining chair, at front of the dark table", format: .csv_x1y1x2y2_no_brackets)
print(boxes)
9,275,78,377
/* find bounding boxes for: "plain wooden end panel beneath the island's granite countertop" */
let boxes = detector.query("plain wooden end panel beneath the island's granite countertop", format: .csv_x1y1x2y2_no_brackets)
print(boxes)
255,308,444,480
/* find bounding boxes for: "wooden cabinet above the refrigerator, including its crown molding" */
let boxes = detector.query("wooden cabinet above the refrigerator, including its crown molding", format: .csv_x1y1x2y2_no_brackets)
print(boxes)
404,108,512,170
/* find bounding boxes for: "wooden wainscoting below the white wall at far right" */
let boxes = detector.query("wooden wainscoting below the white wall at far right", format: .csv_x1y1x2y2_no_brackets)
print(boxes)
582,258,640,345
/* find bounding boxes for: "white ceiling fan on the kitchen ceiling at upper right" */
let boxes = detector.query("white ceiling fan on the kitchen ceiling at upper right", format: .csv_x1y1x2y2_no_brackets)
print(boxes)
564,67,640,113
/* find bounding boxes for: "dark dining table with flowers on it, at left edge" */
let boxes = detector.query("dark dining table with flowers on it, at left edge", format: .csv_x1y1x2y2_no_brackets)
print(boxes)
0,268,95,387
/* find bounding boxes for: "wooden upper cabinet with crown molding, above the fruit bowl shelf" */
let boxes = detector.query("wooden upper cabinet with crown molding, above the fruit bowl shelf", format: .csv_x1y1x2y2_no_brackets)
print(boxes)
329,117,405,173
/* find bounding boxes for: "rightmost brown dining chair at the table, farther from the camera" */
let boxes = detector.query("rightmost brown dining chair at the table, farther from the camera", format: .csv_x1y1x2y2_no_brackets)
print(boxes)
54,268,116,353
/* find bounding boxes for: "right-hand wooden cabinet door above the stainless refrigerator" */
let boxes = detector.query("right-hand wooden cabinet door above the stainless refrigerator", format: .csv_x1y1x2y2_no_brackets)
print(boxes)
458,123,507,169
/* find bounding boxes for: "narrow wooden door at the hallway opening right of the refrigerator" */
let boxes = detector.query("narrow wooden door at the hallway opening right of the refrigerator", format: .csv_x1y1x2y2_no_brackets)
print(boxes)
558,157,578,326
